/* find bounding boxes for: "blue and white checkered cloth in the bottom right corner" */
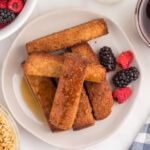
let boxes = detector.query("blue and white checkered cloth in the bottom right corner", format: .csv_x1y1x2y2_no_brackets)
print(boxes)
129,117,150,150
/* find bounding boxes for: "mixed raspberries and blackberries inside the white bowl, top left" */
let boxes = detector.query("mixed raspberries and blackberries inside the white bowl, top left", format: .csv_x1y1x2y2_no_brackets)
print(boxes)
0,0,24,29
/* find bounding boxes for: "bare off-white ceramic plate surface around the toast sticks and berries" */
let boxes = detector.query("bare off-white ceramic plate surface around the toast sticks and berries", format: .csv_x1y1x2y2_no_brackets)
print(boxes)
2,9,141,149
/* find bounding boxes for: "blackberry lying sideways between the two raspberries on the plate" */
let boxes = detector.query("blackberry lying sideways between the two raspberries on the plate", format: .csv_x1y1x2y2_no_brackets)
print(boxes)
113,67,139,88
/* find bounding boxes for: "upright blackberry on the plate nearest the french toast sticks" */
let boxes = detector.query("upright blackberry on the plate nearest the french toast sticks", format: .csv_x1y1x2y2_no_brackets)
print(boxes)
99,46,116,72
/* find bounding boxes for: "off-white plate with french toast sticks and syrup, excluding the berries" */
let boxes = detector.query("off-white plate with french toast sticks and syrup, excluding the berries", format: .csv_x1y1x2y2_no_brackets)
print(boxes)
2,9,141,149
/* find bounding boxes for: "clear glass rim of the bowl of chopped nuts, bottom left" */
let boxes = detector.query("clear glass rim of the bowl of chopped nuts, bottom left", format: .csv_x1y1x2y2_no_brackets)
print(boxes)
0,104,20,150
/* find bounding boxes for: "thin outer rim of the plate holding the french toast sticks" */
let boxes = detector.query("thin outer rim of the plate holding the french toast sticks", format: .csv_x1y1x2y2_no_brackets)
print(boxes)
1,8,143,149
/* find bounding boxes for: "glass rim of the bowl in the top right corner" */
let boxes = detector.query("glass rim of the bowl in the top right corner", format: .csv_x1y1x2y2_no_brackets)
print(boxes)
134,0,150,47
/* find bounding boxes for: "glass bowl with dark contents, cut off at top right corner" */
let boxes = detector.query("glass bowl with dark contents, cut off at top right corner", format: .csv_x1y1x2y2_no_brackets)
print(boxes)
135,0,150,47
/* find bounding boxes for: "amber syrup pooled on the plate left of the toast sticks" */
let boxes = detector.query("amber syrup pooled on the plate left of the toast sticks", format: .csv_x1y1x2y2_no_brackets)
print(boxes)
20,77,46,124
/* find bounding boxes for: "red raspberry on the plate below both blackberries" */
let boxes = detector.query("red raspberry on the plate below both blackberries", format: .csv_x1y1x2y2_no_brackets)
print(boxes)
113,87,132,104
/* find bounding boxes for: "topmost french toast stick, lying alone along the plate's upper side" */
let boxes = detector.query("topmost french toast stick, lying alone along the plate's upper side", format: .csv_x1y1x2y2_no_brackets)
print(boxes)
26,19,108,53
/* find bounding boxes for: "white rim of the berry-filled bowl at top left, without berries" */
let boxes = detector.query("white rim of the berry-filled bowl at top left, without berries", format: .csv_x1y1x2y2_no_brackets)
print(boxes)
0,0,37,41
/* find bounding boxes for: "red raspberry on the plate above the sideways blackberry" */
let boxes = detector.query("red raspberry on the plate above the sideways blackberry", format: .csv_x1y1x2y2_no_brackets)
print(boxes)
116,51,133,69
